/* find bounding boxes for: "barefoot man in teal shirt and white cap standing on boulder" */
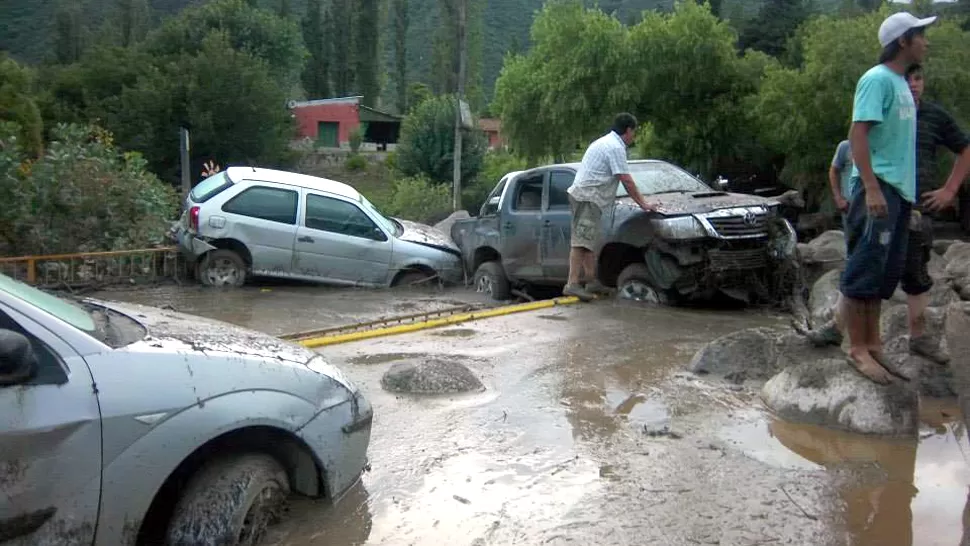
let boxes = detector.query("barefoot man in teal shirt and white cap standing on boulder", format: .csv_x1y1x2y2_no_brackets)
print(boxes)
839,12,936,384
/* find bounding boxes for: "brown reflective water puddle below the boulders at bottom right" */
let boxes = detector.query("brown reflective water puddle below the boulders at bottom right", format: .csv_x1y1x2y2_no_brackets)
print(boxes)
719,400,970,546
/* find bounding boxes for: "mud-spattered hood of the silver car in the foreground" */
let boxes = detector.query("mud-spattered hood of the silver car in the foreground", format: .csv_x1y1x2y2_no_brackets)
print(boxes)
87,299,317,365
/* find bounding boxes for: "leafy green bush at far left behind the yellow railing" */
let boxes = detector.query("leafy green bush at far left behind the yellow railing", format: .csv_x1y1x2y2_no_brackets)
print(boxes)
0,123,178,255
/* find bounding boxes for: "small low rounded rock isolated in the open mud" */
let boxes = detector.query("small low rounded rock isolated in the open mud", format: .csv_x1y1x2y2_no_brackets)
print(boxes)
381,359,485,394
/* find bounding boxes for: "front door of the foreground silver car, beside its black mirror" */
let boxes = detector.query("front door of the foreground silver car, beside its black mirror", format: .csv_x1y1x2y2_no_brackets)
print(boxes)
0,304,101,546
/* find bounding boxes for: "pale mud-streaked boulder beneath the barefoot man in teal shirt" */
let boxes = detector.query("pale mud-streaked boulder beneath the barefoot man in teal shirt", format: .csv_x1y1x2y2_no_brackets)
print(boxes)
761,358,919,436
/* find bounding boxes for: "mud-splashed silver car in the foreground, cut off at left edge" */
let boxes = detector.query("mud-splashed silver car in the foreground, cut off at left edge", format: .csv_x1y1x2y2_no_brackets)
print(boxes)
0,275,373,546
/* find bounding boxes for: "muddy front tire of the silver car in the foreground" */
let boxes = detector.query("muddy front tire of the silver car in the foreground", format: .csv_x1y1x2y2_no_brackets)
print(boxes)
166,453,290,546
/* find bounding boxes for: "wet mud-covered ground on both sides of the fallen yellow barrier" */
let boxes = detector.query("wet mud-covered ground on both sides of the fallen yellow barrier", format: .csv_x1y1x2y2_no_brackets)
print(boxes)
99,286,970,546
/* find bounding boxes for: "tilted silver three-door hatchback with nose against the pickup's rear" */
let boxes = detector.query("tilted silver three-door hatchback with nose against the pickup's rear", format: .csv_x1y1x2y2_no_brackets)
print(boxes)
175,167,464,287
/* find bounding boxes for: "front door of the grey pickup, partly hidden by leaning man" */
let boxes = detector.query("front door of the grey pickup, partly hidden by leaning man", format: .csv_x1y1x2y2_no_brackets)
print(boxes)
540,169,576,283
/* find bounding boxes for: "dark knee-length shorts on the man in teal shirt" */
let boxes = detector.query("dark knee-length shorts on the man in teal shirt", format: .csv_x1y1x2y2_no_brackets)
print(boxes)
839,180,912,300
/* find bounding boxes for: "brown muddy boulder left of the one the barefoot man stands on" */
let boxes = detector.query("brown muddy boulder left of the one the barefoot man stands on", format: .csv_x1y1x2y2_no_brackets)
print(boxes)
687,328,779,383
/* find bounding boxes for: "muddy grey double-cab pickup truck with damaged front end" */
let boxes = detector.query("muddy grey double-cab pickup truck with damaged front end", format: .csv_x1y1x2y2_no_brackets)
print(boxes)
451,160,796,304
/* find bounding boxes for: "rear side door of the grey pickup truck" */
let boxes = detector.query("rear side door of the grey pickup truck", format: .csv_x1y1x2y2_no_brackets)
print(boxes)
499,173,545,280
